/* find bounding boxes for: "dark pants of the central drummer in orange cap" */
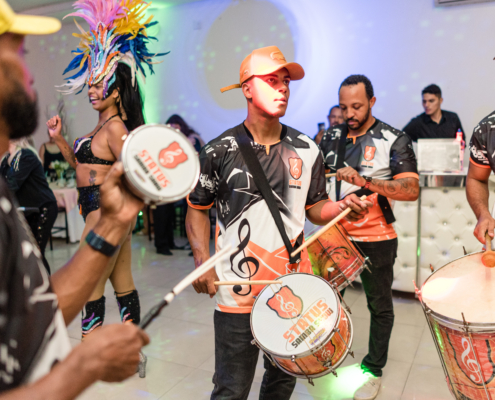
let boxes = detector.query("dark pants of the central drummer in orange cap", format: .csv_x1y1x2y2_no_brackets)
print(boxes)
211,311,296,400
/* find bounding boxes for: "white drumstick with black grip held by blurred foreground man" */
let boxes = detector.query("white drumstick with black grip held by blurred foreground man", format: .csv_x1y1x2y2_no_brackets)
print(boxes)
139,244,238,329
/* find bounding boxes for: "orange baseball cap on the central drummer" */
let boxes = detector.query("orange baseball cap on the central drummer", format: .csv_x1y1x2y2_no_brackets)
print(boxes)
220,46,304,93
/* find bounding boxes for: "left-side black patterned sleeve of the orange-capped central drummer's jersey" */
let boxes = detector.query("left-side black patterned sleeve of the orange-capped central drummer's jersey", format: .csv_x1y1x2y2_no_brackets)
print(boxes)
187,145,219,210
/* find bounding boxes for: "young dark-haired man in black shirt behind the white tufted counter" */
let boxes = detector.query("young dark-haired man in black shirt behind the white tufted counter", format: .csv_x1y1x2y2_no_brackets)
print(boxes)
403,85,466,142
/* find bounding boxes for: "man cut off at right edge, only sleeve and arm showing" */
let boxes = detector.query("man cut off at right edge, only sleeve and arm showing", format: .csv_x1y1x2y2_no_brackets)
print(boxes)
466,111,495,244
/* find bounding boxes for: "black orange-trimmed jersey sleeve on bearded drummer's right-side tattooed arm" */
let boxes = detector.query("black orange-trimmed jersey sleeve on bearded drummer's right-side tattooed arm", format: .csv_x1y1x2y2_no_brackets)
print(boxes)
390,133,419,179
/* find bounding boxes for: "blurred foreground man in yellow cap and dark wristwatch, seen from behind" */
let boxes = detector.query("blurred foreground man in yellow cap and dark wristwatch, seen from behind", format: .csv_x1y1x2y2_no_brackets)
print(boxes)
0,0,149,400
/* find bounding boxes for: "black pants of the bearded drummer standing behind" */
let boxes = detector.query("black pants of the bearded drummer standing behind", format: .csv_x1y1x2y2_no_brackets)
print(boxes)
356,239,398,376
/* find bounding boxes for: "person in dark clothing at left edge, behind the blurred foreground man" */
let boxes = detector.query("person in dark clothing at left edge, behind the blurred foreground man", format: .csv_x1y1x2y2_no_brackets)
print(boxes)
0,138,58,274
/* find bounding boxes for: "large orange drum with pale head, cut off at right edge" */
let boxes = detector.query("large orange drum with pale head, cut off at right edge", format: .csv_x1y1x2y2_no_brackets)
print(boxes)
416,252,495,400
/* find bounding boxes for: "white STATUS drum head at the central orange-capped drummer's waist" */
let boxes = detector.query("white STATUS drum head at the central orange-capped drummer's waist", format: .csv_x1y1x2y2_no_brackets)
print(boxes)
251,273,340,358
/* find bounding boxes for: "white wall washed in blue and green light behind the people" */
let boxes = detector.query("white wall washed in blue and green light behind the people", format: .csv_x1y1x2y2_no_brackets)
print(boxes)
27,0,495,152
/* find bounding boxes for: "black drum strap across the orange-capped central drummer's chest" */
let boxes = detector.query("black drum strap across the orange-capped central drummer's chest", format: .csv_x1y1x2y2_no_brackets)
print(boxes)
234,124,304,264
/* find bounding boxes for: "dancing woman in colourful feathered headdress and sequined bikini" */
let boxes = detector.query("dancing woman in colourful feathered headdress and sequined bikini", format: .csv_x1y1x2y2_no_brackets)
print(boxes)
47,0,164,377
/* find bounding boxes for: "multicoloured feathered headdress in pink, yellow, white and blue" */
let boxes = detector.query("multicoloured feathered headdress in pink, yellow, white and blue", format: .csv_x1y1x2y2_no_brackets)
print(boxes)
60,0,168,95
